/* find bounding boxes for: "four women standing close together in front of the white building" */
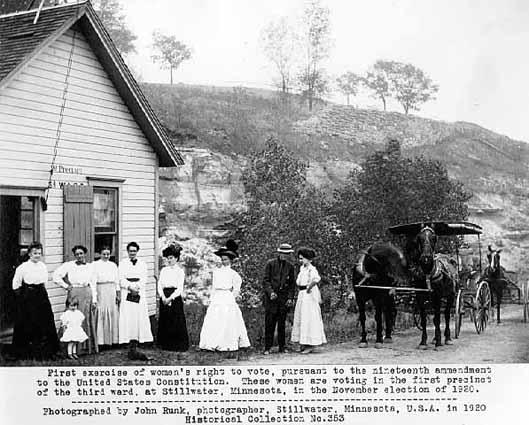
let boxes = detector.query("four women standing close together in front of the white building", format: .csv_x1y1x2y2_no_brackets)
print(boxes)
12,242,157,359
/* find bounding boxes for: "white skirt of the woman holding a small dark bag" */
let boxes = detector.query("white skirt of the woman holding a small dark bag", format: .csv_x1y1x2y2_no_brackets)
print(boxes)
119,289,153,344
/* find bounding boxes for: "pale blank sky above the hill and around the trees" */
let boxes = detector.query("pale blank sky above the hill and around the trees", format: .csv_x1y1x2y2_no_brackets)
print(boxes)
122,0,529,142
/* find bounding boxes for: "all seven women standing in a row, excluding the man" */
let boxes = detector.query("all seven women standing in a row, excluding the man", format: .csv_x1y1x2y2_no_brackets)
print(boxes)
12,237,326,360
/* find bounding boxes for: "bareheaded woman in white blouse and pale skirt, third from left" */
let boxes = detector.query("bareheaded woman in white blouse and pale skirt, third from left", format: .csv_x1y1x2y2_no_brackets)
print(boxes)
92,246,121,348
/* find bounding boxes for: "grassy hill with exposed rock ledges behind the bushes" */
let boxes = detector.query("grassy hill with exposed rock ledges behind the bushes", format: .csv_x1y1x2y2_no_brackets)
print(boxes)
139,84,529,280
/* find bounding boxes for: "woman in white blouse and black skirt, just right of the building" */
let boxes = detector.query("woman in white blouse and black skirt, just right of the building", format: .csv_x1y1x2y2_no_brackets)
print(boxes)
158,245,189,351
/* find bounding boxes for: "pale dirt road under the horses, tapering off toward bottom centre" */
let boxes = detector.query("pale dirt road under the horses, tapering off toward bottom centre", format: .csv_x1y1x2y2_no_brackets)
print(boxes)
236,305,529,365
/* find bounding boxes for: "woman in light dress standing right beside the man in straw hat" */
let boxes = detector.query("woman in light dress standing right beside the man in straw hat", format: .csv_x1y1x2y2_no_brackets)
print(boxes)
292,248,327,354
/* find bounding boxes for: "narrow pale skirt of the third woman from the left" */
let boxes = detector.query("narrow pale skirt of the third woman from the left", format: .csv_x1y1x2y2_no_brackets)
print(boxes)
97,282,119,345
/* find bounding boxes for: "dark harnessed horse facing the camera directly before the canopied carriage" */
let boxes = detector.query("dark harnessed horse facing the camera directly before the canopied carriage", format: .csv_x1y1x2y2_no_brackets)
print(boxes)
412,226,457,349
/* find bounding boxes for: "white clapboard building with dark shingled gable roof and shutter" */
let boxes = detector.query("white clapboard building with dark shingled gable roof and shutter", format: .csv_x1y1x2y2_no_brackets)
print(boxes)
0,1,182,336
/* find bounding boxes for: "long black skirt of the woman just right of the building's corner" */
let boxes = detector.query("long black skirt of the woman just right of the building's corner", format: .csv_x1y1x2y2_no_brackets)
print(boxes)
158,288,189,351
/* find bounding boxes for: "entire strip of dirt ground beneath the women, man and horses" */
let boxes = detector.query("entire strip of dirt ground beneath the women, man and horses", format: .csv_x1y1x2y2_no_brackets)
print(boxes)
0,305,529,366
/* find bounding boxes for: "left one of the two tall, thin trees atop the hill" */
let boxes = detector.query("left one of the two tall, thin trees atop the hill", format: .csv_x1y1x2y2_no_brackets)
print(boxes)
260,17,296,94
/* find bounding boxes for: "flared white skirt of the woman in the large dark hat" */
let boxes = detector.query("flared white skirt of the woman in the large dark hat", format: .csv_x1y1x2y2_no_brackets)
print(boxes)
199,290,250,351
